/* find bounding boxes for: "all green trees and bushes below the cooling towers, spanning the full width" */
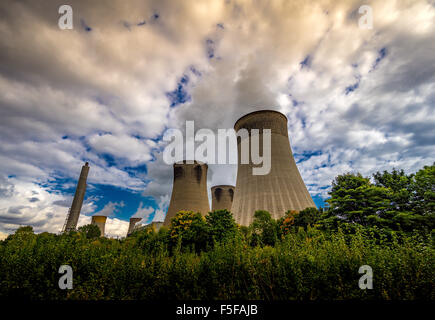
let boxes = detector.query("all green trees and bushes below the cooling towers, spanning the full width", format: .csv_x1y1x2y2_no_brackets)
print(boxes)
0,162,435,300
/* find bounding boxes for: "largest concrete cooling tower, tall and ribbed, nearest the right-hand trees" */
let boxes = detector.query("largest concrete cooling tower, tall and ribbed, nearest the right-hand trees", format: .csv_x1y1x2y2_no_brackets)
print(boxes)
231,110,315,226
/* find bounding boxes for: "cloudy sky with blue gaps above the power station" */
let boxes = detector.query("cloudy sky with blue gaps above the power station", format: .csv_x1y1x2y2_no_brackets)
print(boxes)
0,0,435,236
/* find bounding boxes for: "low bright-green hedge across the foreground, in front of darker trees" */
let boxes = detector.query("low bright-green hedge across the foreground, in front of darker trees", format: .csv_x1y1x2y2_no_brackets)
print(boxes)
0,227,435,300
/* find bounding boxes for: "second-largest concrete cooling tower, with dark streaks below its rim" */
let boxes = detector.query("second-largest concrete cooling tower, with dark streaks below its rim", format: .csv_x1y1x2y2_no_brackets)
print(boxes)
163,161,210,226
